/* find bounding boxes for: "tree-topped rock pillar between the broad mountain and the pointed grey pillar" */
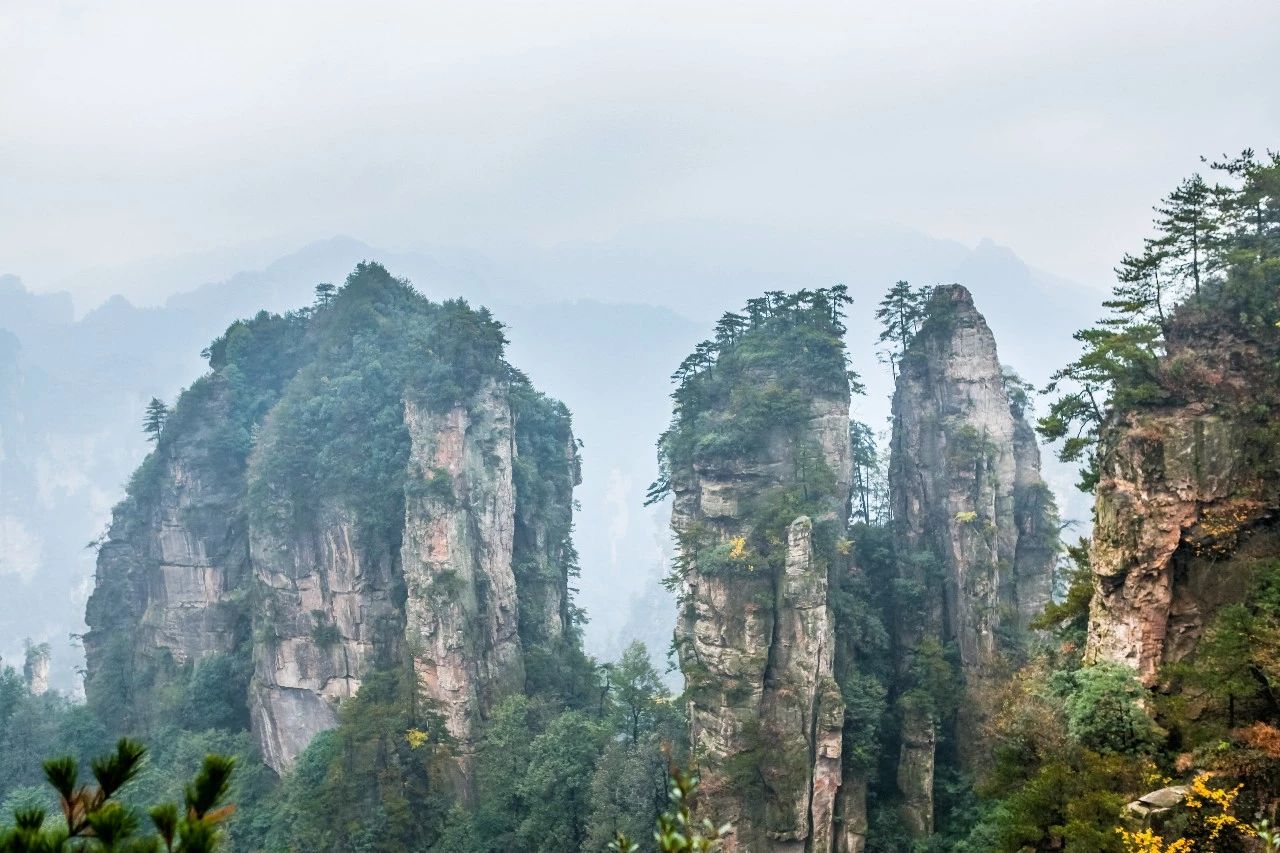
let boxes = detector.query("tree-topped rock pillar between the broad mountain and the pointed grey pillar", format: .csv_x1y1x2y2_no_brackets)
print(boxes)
660,291,861,850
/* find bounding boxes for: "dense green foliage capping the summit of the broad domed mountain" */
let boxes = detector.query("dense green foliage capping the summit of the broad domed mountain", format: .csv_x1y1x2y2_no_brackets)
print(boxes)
244,263,511,548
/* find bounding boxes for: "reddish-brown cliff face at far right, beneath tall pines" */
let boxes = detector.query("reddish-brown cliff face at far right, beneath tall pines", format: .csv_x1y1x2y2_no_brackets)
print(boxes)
1085,312,1280,686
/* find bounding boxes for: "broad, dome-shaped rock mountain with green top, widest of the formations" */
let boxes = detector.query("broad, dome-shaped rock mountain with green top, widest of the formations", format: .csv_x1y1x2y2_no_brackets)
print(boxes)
86,268,577,786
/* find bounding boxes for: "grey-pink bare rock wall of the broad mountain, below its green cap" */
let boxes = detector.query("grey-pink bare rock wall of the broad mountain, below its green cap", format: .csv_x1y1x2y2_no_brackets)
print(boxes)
86,382,577,778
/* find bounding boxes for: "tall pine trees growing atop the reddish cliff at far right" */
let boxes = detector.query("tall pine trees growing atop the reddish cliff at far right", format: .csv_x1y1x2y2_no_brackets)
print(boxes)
1037,150,1280,491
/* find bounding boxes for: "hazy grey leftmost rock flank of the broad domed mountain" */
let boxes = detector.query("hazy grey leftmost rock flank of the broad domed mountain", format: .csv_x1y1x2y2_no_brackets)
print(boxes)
84,379,250,730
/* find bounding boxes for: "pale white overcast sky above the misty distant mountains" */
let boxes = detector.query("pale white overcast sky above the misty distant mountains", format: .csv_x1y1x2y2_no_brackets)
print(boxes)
0,0,1280,297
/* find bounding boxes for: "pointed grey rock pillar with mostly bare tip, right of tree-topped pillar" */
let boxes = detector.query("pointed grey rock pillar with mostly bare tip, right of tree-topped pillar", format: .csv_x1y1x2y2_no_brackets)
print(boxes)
890,286,1057,835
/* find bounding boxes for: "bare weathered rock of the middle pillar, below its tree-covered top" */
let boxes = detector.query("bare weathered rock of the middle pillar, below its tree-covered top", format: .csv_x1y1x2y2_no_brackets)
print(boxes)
672,386,859,850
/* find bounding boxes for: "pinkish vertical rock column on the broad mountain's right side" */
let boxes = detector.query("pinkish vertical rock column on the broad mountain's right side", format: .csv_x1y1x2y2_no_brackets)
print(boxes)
403,386,525,783
